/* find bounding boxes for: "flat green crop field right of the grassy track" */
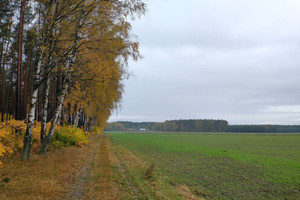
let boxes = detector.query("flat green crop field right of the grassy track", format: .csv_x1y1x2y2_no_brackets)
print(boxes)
107,132,300,199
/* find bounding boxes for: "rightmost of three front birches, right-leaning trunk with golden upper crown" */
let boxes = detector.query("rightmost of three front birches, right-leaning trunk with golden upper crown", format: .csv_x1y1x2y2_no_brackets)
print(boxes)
41,1,145,153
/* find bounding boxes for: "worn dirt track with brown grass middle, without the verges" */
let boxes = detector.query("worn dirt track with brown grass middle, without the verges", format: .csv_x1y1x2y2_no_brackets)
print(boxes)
68,135,121,200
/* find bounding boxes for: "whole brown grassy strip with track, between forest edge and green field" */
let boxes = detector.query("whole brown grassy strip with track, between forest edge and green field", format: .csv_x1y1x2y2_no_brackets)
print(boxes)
0,135,197,200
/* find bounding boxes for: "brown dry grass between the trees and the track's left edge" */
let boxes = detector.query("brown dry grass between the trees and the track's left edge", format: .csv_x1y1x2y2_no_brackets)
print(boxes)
0,135,101,200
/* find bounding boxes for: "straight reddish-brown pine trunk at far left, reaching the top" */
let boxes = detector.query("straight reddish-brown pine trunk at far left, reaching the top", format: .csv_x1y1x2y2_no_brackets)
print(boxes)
16,0,26,120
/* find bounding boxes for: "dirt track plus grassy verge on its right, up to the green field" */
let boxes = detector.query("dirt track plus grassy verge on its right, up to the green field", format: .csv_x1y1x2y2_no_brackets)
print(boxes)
67,135,197,200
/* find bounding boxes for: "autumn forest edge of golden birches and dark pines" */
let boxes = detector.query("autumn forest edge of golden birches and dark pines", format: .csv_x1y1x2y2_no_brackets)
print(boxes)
0,0,146,160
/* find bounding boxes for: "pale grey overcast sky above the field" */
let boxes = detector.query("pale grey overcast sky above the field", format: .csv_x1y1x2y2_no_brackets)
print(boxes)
109,0,300,124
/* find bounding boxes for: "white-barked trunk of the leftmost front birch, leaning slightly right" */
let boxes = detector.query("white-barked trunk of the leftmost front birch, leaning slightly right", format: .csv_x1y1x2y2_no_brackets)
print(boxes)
21,50,43,160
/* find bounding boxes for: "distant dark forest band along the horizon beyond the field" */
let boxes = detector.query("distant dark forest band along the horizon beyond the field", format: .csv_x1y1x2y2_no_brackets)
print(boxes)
104,119,300,133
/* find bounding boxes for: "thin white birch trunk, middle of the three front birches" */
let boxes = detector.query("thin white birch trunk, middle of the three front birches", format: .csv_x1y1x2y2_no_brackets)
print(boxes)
41,76,50,145
